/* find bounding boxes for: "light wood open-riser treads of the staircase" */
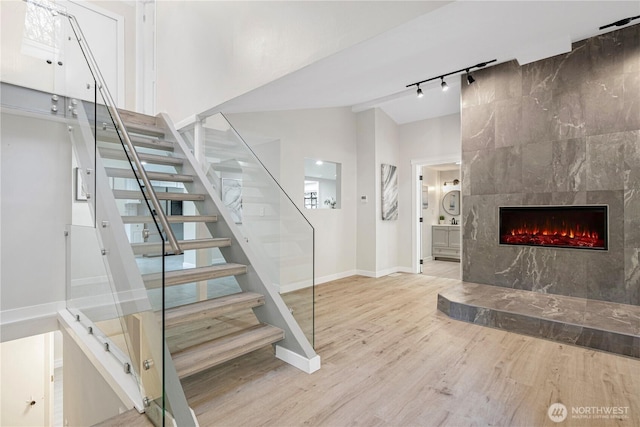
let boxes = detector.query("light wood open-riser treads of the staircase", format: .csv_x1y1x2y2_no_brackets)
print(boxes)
98,111,284,378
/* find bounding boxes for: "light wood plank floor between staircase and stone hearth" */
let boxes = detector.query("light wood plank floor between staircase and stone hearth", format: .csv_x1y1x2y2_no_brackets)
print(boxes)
183,274,640,427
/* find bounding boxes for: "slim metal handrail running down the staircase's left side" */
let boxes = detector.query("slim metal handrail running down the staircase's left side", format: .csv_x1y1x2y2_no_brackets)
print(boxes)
25,0,182,255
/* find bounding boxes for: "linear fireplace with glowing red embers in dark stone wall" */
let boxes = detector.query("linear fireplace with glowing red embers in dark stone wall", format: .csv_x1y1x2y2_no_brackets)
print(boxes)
500,206,608,250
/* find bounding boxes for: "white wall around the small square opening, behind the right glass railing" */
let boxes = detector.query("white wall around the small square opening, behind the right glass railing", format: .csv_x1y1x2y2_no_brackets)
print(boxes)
228,108,356,283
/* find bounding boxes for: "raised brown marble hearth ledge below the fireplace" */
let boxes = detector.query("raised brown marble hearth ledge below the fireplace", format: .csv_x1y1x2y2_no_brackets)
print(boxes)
438,282,640,358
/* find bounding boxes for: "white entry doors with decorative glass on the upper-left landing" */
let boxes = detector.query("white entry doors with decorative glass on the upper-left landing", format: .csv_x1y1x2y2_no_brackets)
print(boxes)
0,1,124,106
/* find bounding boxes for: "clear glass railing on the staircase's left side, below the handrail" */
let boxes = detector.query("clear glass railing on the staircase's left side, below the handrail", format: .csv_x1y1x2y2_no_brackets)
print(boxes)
16,1,196,426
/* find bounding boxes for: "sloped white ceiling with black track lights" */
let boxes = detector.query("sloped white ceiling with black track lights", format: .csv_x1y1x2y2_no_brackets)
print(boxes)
221,0,640,124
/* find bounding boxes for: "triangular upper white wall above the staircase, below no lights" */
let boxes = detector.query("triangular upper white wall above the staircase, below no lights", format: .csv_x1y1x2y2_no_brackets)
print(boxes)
156,1,442,122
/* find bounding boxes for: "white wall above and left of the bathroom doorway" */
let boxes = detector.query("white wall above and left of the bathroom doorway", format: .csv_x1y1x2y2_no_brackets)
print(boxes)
398,114,461,267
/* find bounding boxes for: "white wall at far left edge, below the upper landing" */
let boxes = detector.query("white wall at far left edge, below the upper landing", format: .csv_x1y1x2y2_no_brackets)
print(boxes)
0,114,72,318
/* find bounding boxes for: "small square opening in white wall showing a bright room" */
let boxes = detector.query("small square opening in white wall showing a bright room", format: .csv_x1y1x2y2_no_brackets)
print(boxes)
304,158,342,209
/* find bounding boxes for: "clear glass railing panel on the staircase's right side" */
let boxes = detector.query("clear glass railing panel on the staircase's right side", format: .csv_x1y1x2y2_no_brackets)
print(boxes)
181,113,315,345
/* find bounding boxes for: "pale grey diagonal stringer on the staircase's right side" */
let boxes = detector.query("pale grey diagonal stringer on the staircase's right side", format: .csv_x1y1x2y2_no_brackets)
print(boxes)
159,113,320,373
